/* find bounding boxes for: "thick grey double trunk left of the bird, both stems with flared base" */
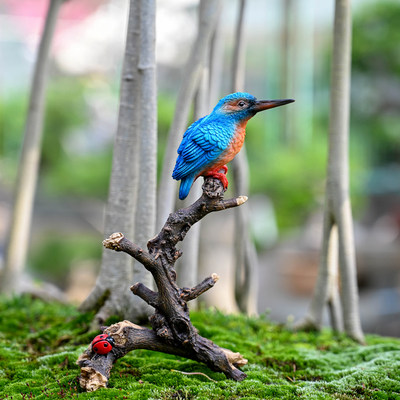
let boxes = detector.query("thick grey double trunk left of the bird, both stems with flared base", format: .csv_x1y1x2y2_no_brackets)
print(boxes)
81,0,157,325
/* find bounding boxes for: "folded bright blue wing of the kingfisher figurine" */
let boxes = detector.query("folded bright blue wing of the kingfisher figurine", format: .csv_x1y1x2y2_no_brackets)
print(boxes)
172,118,233,180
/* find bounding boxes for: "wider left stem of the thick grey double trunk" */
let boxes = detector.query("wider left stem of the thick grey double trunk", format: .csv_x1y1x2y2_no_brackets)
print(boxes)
80,0,147,329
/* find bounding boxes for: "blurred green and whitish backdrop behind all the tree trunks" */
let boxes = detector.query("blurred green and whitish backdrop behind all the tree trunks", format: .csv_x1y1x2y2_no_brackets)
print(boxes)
0,0,400,336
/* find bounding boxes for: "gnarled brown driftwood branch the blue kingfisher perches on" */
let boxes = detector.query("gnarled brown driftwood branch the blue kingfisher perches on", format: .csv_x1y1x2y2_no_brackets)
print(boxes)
77,178,247,391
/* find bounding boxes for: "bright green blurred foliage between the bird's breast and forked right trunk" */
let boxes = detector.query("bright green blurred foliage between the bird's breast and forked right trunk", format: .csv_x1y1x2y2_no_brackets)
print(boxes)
246,119,327,231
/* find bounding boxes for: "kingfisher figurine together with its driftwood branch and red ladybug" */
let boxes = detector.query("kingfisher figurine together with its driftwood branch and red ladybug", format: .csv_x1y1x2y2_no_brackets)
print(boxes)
78,93,293,391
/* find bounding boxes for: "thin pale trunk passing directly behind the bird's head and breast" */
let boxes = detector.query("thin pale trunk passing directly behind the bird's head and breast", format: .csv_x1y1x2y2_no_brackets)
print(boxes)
231,0,258,314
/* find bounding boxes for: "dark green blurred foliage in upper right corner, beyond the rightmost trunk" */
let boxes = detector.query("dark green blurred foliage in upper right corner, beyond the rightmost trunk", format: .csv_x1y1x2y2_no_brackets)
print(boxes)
352,0,400,167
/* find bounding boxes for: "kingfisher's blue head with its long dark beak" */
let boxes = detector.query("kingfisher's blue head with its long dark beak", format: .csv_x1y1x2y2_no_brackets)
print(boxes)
213,92,294,121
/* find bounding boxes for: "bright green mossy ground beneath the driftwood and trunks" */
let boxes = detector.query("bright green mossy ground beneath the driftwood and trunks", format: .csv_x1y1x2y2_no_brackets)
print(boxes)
0,296,400,400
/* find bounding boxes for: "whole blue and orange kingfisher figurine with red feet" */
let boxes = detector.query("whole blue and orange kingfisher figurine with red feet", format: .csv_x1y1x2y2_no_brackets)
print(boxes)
172,92,294,200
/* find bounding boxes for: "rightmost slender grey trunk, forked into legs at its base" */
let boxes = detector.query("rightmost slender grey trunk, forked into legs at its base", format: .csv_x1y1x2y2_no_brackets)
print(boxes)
299,0,364,343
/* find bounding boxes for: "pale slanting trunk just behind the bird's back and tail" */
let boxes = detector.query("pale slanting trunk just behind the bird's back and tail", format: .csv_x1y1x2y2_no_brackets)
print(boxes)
157,0,222,230
